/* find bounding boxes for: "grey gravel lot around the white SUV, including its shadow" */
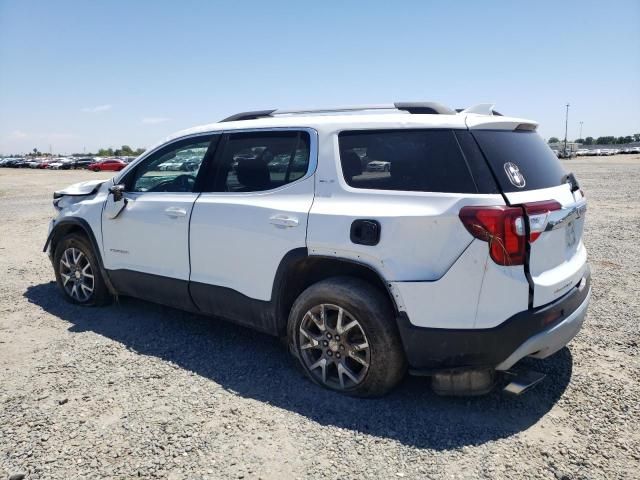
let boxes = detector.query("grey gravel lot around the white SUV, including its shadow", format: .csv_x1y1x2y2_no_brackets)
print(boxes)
0,156,640,479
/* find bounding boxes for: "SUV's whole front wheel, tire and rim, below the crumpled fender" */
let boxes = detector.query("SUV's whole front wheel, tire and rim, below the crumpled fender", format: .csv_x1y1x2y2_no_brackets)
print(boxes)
53,234,111,305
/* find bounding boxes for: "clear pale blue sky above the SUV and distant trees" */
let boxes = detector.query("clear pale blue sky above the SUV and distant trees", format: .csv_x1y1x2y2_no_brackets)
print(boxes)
0,0,640,154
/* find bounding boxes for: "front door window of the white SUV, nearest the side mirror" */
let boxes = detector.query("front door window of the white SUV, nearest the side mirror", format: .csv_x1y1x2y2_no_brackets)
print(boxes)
127,136,211,192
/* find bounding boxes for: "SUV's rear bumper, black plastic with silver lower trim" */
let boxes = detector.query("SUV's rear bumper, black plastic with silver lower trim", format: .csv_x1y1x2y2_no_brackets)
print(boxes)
398,268,591,375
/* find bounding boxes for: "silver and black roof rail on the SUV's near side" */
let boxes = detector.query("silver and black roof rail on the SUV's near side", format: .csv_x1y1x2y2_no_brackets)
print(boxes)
220,102,456,122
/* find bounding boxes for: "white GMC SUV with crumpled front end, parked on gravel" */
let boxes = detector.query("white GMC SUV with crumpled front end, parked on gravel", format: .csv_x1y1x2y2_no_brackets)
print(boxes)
45,103,590,396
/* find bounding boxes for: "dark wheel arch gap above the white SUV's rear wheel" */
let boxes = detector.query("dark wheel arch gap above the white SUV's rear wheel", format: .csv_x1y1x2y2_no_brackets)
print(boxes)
271,248,399,335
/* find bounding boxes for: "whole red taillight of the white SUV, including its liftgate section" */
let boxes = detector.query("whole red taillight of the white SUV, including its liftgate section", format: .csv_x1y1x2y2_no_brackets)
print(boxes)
459,201,562,265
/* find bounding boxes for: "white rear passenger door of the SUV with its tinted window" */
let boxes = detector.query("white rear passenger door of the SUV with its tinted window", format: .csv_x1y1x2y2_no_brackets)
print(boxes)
190,129,317,330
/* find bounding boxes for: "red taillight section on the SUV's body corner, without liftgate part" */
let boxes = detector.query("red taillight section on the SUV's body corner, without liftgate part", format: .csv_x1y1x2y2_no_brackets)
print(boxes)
459,206,526,265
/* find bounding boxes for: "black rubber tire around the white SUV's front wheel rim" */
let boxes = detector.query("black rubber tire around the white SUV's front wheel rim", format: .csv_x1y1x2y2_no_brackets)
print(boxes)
53,233,112,306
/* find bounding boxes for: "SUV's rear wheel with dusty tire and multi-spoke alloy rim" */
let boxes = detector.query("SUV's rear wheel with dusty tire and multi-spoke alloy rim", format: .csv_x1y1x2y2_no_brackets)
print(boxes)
288,277,406,397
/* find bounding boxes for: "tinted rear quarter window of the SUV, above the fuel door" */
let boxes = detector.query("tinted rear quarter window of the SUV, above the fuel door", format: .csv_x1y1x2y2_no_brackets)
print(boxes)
339,129,478,193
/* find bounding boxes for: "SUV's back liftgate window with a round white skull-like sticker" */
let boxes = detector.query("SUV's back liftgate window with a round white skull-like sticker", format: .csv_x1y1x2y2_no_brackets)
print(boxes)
472,130,567,192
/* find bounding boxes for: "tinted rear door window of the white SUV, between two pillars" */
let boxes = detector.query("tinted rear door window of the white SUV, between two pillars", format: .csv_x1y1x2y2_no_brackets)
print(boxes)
214,131,309,192
